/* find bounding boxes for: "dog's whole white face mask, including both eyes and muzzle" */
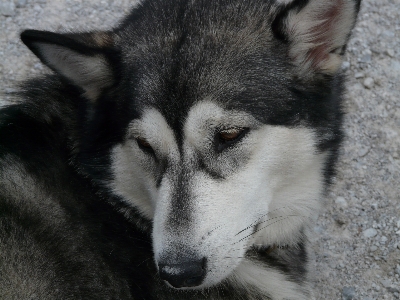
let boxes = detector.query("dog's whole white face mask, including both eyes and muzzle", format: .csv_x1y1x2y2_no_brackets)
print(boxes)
111,100,325,287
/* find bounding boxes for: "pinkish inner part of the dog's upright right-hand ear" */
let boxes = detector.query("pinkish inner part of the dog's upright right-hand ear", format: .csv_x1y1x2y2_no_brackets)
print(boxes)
306,0,344,68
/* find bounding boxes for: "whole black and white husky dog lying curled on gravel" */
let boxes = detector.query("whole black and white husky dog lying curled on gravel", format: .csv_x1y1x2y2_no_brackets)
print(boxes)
0,0,360,300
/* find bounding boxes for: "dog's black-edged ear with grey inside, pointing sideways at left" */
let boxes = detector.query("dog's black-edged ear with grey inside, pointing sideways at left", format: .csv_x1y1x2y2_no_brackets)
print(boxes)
21,30,115,101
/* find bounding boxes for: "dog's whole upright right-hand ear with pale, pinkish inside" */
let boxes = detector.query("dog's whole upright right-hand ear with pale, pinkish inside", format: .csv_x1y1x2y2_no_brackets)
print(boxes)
272,0,360,77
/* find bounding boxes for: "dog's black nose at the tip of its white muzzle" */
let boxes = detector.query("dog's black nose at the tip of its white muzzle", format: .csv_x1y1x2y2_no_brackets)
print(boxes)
158,258,206,288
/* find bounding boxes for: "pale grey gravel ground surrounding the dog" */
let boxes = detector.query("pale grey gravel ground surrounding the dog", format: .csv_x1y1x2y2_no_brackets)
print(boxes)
0,0,400,300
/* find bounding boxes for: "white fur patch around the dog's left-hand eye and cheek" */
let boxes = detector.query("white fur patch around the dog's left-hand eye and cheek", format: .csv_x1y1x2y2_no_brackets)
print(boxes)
110,108,179,219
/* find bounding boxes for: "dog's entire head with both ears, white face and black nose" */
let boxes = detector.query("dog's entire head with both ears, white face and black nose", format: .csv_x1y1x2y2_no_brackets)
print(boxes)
22,0,359,288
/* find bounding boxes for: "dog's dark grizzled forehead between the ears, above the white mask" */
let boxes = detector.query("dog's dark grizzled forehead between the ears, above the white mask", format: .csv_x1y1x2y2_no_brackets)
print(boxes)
118,0,291,131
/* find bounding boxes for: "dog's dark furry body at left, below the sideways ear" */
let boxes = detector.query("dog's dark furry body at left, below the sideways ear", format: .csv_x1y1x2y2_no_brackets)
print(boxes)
0,77,152,299
